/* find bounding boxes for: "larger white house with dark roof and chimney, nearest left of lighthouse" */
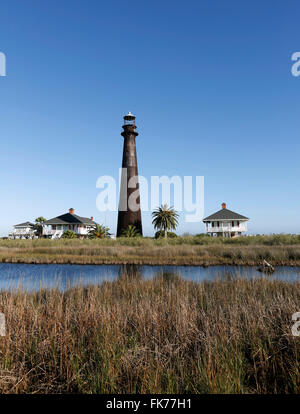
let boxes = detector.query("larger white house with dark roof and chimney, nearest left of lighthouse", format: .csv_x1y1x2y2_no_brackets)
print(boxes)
43,208,97,239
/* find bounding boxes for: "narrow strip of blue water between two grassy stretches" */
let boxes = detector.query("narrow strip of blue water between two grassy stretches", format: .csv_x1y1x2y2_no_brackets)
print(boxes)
0,263,300,291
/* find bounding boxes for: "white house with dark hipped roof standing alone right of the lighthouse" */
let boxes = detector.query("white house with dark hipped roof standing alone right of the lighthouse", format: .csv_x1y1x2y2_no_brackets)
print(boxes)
203,203,249,237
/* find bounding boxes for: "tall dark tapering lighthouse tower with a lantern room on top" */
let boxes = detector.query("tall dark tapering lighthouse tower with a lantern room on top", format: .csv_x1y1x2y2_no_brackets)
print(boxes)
117,112,143,237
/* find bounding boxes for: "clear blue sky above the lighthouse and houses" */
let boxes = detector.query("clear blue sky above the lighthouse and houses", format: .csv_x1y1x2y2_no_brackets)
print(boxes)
0,0,300,235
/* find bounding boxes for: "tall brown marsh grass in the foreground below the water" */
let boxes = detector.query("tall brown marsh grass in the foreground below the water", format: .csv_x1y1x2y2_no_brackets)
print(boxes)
0,275,300,393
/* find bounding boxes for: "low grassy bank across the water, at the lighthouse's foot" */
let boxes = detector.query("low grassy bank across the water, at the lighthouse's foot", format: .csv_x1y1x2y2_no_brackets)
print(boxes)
0,235,300,266
